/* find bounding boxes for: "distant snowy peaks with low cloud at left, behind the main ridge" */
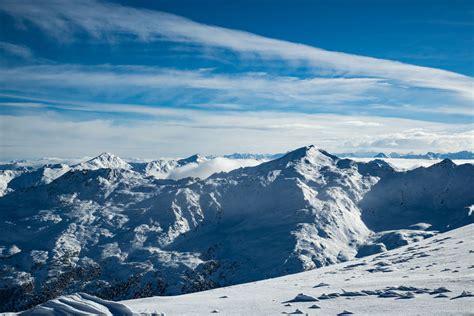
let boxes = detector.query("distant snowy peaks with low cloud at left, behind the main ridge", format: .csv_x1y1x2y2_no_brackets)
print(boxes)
0,153,265,196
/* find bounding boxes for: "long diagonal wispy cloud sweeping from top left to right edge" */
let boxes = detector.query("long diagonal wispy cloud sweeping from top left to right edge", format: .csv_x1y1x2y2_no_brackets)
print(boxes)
0,0,474,100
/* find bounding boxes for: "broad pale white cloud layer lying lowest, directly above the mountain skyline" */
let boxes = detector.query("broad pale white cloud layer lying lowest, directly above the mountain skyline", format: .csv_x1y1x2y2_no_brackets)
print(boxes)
0,110,474,160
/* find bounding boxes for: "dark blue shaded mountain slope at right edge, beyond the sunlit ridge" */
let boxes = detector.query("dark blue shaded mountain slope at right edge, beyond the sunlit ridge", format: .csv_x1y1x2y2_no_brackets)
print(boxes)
360,159,474,231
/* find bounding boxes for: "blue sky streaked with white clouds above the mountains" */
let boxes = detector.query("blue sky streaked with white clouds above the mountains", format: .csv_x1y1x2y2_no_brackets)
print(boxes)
0,0,474,160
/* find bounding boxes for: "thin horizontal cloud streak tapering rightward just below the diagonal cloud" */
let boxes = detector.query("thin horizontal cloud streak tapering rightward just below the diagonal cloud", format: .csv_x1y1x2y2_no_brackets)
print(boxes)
0,65,386,98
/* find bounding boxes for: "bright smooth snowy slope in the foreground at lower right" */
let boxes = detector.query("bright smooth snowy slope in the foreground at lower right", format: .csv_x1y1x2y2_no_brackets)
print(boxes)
14,224,474,315
